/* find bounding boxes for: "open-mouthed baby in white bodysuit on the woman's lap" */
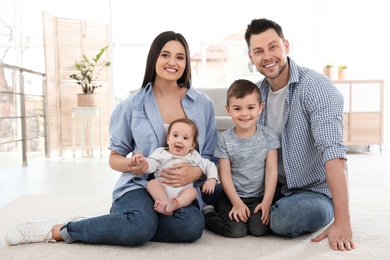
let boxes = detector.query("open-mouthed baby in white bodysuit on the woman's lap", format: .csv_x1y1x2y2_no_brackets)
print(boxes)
132,118,218,215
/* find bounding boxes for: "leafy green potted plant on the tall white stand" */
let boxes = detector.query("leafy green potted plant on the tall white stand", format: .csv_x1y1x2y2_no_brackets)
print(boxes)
69,45,111,106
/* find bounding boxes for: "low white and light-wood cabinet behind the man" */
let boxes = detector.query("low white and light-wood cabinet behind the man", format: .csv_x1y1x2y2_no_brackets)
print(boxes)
334,80,384,152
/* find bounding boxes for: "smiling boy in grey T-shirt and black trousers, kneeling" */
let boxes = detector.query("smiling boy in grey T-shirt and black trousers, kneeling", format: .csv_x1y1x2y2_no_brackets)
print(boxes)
205,79,280,238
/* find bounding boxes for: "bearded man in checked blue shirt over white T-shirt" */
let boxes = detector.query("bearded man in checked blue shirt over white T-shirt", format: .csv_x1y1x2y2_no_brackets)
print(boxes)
245,19,355,251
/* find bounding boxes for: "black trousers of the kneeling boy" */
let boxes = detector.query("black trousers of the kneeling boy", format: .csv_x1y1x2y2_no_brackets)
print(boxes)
206,191,271,238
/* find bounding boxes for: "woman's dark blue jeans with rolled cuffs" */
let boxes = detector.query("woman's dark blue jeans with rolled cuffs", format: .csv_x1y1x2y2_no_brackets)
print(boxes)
60,188,205,246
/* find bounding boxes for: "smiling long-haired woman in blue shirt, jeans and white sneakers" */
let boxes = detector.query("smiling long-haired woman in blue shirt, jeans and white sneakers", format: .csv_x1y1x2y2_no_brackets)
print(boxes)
6,31,218,246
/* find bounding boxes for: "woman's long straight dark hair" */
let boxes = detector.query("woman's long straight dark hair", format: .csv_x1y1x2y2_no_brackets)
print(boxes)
141,31,191,88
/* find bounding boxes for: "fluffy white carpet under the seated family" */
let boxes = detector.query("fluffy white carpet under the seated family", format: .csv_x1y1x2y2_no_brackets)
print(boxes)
0,189,390,260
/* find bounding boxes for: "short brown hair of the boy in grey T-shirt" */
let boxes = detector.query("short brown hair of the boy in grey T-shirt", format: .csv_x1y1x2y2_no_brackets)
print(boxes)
226,79,262,106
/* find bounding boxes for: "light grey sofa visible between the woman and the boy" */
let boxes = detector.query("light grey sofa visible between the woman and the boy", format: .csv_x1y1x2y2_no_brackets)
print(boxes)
196,88,233,133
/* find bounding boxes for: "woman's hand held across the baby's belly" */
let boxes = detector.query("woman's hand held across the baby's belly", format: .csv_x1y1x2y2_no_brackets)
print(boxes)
160,163,203,187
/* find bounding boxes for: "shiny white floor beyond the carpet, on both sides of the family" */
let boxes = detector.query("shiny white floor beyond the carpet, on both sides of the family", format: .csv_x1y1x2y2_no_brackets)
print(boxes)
0,147,390,208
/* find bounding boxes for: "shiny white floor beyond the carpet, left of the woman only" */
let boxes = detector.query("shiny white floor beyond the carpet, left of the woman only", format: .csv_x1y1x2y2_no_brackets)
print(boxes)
0,150,119,208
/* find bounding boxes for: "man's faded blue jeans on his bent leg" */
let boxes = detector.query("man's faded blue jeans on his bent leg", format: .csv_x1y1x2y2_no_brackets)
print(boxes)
270,187,334,237
